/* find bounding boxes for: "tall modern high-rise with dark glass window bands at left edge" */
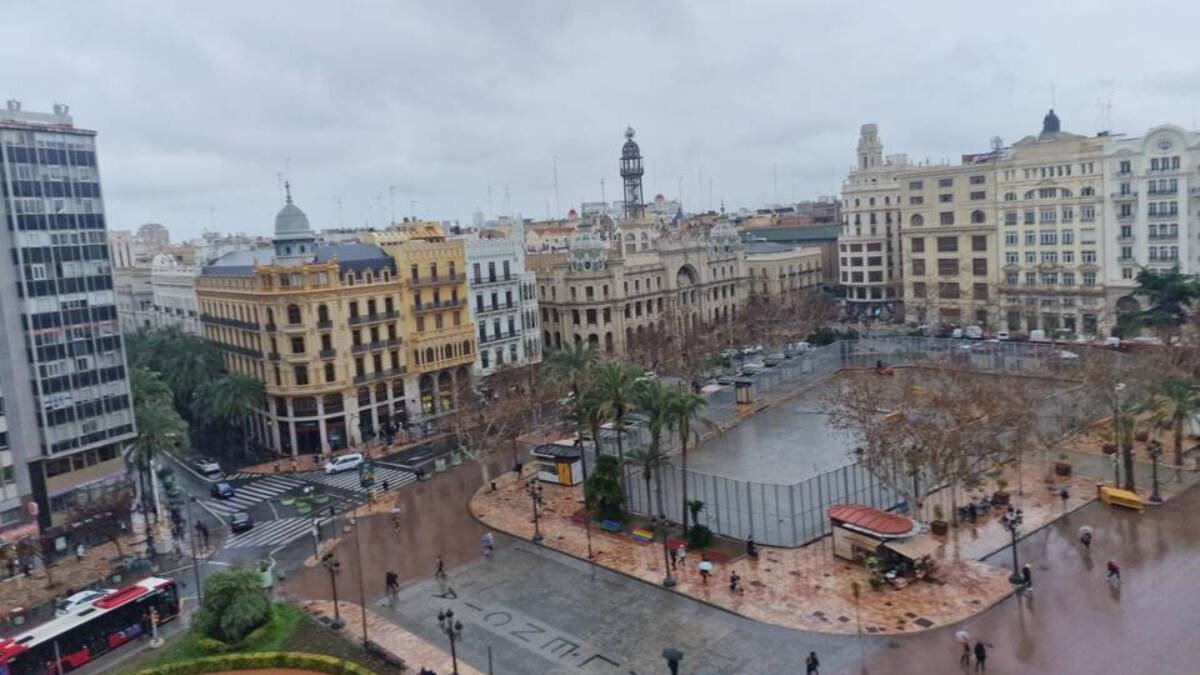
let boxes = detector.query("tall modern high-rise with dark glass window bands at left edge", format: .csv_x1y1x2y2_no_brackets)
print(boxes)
0,101,134,533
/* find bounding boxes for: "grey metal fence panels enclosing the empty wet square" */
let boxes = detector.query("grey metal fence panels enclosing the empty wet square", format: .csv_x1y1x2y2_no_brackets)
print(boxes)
589,336,1105,546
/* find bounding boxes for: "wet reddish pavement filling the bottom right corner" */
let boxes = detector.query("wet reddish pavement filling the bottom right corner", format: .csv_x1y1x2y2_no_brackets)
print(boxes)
846,489,1200,675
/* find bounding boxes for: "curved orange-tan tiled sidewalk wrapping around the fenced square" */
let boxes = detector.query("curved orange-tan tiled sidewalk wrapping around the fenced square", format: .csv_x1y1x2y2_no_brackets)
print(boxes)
470,458,1096,634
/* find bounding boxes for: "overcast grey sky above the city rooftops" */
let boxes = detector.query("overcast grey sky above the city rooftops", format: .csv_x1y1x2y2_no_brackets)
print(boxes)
0,0,1200,237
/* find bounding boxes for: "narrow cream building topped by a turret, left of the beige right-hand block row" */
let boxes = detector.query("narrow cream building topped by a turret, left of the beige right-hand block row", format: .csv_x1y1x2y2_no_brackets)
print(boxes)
838,124,919,319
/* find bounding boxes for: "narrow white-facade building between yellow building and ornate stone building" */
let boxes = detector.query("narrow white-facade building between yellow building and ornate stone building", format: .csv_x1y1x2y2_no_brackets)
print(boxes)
464,233,542,375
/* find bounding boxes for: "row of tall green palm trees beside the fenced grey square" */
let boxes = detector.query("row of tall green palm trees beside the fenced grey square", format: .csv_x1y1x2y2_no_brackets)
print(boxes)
542,345,712,533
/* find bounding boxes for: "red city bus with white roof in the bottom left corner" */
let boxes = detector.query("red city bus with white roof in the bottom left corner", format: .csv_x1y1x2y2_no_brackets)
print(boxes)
0,577,180,675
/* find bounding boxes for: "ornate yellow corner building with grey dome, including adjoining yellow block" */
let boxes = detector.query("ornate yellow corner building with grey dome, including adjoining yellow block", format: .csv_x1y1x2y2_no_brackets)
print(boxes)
196,187,475,454
